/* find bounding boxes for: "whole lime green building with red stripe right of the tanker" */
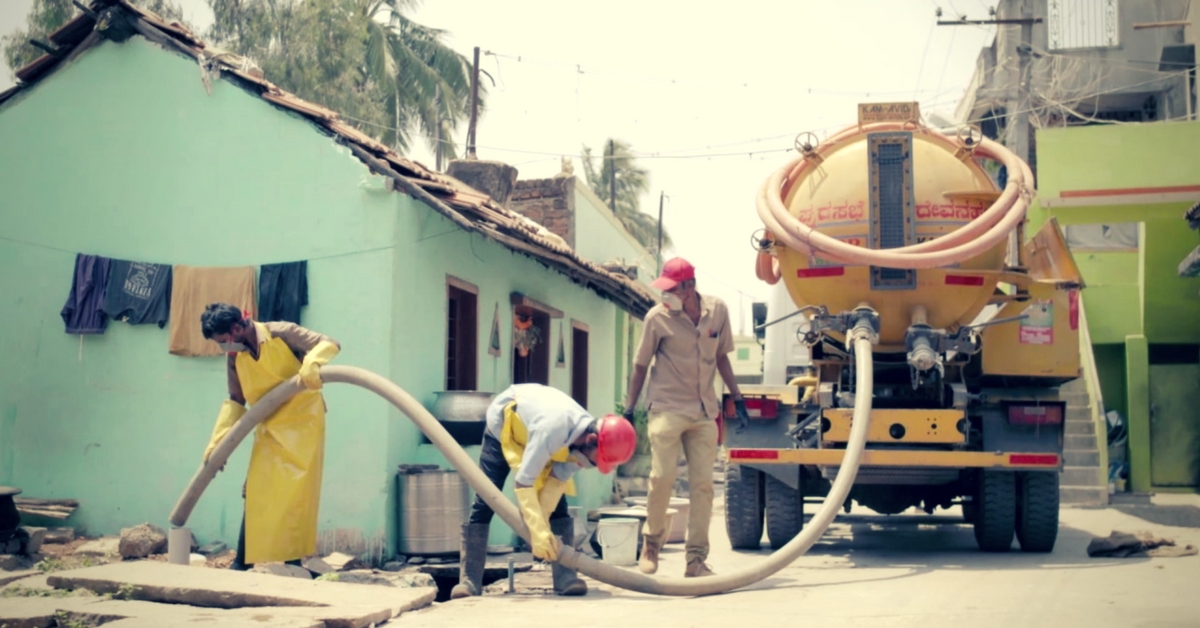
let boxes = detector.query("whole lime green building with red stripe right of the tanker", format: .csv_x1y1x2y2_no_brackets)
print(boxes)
1027,121,1200,491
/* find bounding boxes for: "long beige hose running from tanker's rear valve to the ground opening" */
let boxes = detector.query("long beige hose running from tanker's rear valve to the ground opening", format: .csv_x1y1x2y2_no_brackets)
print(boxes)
168,327,874,596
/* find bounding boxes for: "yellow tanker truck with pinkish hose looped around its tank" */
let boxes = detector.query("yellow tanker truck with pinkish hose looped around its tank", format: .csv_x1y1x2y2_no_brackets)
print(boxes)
725,103,1082,551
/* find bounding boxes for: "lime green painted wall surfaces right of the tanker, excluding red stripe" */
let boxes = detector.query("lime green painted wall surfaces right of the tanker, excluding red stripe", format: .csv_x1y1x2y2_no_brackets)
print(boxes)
1028,122,1200,491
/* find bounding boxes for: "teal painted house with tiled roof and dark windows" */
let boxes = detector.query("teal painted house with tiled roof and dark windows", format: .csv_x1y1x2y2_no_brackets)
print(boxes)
0,0,653,558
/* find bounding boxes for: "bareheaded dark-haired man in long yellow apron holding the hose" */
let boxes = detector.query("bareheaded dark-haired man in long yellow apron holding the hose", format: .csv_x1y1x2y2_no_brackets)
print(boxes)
200,303,341,569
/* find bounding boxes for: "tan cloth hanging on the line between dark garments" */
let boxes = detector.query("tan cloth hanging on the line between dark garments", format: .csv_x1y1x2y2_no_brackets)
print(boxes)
168,265,254,355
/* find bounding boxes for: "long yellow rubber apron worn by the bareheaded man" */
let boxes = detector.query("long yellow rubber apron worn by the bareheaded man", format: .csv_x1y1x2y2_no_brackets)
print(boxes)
235,323,325,563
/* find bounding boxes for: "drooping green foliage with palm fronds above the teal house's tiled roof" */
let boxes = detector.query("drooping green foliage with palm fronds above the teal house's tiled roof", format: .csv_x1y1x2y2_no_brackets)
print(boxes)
208,0,486,159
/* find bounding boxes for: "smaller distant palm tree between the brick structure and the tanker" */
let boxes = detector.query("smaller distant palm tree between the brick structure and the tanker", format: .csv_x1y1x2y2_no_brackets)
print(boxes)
582,138,671,255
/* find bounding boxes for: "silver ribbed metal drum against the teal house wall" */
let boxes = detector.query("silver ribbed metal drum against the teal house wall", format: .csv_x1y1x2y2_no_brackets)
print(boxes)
396,465,470,555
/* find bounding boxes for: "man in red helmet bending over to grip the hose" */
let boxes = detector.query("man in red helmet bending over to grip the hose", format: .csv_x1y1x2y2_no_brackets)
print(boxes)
450,384,637,598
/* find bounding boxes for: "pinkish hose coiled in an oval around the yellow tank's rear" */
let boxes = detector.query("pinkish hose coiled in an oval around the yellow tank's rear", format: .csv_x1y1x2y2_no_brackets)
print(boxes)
756,122,1033,270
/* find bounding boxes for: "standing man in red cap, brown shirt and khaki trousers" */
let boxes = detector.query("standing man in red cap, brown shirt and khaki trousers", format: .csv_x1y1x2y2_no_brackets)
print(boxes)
625,257,748,578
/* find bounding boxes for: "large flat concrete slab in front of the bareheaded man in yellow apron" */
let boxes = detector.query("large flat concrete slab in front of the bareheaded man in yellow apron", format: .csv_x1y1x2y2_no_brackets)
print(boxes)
48,561,437,628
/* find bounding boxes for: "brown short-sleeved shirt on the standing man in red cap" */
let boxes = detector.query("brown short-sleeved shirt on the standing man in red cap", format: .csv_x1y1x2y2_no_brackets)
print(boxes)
634,294,733,418
